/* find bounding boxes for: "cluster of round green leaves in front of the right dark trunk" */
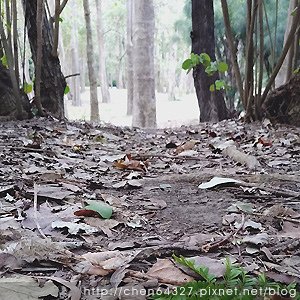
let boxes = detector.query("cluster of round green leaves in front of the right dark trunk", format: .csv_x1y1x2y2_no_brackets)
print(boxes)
182,53,228,92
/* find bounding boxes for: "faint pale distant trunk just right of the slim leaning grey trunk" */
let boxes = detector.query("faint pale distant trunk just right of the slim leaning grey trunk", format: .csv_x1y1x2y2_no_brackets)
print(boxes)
95,0,110,103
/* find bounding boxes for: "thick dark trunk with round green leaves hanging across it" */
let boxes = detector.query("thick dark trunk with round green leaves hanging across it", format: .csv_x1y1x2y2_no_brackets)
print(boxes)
192,0,227,122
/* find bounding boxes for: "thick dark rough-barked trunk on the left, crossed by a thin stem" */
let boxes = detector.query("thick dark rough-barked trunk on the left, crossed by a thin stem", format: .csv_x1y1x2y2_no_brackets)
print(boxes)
23,0,66,119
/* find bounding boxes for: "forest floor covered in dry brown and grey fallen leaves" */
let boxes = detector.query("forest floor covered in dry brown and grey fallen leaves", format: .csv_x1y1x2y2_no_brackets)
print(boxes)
0,119,300,300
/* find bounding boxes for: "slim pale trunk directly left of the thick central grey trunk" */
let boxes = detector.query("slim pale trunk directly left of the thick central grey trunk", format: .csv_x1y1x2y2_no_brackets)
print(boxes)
126,0,133,116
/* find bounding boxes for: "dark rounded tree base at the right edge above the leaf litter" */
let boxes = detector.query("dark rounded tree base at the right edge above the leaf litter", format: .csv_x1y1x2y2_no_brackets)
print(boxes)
263,74,300,126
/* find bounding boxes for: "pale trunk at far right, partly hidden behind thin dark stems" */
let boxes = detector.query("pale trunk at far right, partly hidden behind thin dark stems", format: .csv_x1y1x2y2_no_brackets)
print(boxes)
275,0,299,87
